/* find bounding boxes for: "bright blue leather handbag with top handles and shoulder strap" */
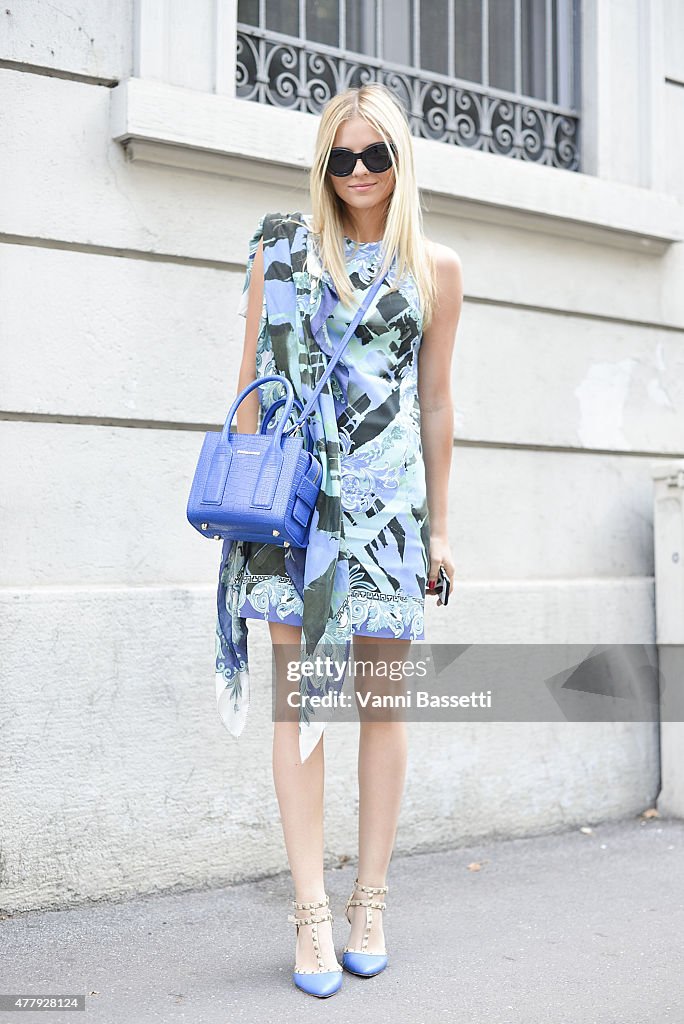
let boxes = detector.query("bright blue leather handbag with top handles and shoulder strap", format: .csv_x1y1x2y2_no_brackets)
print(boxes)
187,253,386,548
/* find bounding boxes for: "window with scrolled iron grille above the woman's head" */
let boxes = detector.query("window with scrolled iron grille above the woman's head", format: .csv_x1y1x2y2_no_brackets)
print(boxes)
238,0,580,171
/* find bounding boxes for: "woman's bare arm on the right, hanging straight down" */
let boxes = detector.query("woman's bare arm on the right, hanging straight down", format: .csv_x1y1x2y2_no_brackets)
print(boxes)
418,245,463,604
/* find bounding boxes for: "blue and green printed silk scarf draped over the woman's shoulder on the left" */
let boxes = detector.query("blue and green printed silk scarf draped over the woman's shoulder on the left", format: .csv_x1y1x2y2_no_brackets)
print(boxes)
211,213,351,761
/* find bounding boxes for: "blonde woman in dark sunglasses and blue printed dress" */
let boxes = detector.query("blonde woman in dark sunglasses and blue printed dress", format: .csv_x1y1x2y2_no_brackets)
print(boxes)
217,83,463,996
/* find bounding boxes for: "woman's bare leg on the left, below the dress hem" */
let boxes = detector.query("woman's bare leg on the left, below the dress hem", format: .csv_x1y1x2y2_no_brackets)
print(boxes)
268,623,338,971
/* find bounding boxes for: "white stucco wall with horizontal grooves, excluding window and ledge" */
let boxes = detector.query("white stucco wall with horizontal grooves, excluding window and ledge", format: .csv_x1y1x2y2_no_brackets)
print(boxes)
0,0,684,910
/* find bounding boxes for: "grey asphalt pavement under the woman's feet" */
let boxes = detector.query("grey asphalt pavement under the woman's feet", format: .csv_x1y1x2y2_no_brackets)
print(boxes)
0,817,684,1024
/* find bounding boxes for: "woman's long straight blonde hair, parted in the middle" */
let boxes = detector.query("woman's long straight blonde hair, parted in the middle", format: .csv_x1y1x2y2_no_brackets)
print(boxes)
309,82,436,329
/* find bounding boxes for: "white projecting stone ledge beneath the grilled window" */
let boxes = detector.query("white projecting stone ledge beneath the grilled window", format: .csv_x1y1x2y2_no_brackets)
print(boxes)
112,78,684,254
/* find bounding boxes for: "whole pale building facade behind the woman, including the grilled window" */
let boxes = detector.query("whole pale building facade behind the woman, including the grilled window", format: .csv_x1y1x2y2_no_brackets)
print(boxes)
0,0,684,909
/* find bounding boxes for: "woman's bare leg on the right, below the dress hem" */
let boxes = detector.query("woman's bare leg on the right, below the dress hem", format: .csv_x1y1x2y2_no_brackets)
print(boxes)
348,636,411,953
